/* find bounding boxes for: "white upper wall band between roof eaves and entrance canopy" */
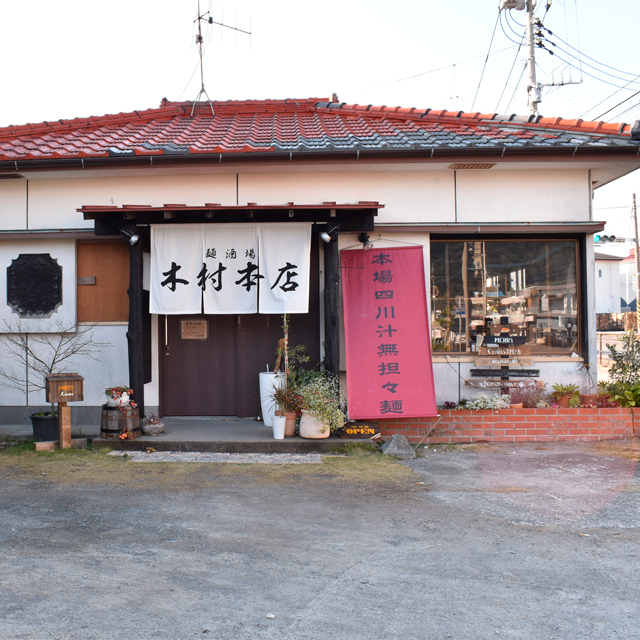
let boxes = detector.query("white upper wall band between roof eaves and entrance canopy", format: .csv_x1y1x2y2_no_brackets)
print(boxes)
0,164,590,230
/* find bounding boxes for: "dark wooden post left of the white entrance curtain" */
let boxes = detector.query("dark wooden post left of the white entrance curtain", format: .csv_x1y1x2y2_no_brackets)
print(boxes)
127,232,144,416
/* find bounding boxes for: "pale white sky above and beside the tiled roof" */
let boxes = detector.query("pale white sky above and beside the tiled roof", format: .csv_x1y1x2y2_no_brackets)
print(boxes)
0,0,640,248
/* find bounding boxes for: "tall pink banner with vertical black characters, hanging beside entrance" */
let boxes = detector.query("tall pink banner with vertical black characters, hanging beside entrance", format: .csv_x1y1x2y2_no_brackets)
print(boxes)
340,247,438,420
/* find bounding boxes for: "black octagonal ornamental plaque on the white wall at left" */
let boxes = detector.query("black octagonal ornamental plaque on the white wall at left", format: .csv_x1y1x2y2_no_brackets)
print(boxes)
7,253,62,318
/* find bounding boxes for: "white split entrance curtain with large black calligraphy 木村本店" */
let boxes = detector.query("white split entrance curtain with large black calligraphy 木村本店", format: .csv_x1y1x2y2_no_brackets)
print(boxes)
149,222,312,320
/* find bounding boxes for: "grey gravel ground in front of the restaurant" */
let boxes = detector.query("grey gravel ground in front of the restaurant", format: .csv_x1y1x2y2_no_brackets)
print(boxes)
0,442,640,640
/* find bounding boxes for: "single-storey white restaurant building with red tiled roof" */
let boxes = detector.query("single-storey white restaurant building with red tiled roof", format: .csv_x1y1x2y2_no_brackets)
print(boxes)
0,99,640,423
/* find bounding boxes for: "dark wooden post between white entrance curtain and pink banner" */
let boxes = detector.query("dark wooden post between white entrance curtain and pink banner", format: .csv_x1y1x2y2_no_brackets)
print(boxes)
324,233,340,375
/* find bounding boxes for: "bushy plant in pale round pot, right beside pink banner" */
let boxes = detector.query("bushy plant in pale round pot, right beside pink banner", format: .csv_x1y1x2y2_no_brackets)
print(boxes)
299,372,345,439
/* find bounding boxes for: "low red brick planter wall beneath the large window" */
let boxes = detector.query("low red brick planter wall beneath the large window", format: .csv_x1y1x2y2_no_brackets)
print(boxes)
379,408,640,444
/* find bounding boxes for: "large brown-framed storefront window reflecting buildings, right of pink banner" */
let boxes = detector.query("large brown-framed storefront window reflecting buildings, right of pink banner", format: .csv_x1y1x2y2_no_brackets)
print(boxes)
431,240,580,354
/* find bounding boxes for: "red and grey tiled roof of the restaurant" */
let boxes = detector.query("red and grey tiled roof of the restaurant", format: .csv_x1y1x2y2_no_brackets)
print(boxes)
0,98,640,168
